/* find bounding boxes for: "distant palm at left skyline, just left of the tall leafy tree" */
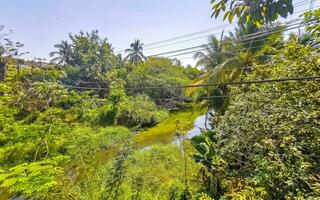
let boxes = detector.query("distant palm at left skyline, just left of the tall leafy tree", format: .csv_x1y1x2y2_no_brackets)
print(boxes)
49,40,72,65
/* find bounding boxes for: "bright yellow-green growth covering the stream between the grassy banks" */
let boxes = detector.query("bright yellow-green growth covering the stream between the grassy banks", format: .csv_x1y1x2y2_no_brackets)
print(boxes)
135,111,200,148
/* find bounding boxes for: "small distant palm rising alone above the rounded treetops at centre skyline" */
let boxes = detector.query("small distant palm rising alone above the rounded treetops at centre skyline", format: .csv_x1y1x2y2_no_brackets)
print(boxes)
125,39,146,65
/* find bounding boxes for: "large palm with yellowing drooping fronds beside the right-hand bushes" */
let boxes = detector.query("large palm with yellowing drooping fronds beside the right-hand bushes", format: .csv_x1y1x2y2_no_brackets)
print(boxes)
186,24,282,120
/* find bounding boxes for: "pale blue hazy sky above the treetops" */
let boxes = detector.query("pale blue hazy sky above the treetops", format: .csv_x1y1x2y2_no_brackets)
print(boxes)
0,0,320,64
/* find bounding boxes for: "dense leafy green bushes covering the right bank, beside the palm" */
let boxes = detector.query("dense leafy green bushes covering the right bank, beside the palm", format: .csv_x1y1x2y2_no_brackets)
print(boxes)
192,8,320,199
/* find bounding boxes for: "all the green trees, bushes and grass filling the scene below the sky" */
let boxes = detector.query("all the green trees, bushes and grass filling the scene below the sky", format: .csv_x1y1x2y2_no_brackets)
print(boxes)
0,1,320,200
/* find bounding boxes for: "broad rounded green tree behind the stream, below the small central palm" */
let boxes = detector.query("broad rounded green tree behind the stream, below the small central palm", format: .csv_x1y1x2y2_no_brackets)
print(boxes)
127,58,201,109
